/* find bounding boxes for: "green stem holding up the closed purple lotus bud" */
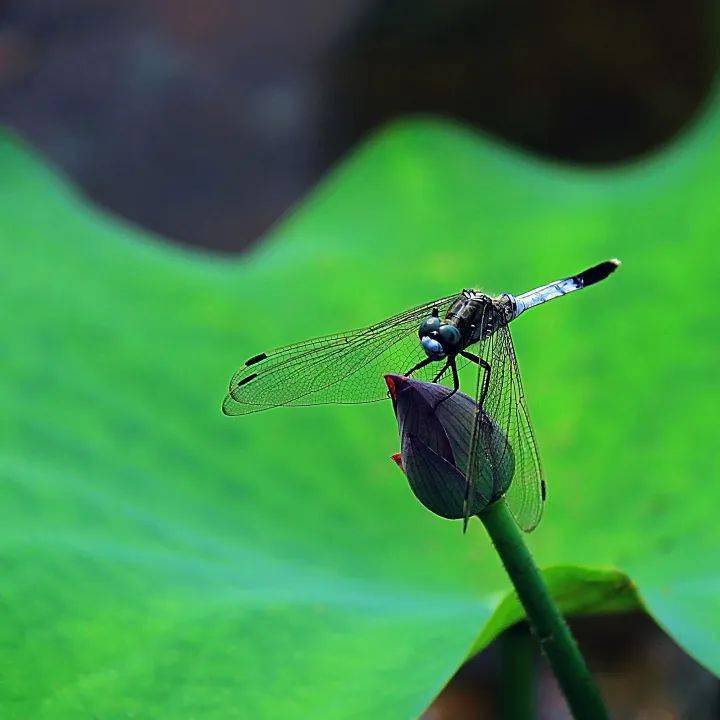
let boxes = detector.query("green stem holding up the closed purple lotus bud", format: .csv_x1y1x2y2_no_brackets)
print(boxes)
478,499,609,720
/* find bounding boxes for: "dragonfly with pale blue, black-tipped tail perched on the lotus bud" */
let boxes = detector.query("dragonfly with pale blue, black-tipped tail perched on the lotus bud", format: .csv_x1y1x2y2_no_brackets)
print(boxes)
222,259,620,532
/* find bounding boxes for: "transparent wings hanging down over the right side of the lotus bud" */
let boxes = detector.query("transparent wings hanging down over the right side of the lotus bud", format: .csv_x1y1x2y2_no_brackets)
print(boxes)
465,326,545,532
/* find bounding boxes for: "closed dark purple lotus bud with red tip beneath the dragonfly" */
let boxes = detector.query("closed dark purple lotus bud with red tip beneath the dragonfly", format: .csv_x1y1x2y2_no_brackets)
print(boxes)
385,375,515,520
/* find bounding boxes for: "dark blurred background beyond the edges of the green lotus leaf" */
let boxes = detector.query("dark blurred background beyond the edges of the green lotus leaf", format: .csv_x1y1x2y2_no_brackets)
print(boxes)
0,0,720,720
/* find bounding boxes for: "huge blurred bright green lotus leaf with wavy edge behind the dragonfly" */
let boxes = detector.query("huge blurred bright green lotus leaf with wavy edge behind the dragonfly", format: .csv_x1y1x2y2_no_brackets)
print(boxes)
0,90,720,720
